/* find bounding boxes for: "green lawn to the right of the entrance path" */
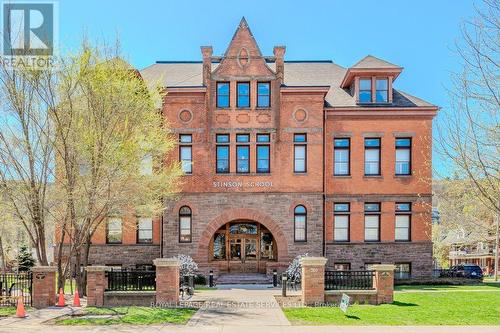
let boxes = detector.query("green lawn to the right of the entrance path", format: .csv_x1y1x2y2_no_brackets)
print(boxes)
283,285,500,325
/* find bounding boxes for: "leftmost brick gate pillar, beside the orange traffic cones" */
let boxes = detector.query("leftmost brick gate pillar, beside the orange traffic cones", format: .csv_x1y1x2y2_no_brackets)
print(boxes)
31,266,57,309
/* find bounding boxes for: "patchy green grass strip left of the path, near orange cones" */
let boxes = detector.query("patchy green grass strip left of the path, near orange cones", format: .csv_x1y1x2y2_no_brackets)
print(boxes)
55,306,197,325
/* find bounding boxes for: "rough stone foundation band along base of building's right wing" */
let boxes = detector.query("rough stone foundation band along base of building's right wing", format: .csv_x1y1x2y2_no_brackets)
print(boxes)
326,242,433,278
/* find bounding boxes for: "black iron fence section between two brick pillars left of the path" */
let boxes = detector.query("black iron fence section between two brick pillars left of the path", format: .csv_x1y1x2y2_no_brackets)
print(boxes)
106,270,156,291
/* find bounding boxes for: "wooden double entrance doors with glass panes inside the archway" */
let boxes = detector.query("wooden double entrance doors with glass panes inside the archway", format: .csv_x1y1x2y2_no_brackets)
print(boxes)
229,235,259,273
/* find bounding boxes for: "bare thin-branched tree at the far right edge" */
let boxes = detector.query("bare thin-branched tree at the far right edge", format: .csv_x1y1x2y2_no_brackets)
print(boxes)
438,0,500,279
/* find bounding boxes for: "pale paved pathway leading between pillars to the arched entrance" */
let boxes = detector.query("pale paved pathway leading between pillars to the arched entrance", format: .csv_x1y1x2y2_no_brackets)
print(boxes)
188,285,290,327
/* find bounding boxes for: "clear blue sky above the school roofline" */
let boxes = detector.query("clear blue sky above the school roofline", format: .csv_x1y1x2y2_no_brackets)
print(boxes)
59,0,474,176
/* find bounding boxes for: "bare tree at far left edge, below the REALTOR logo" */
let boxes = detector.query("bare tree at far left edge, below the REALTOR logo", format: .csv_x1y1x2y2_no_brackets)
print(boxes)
0,62,54,265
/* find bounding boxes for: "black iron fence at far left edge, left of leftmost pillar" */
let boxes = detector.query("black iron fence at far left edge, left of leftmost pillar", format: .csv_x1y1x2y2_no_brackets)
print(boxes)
0,272,33,306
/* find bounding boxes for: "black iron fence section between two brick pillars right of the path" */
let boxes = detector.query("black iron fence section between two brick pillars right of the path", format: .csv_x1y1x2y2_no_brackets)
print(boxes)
325,271,375,290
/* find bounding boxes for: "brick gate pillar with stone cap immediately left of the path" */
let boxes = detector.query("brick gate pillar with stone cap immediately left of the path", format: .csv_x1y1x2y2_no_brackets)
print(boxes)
153,258,180,304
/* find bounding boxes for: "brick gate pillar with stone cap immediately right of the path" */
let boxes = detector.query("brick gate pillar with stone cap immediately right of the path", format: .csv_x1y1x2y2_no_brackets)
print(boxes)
300,257,328,305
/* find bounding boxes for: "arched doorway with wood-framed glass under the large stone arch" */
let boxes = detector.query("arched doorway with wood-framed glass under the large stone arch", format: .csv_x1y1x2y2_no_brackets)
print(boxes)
208,220,278,273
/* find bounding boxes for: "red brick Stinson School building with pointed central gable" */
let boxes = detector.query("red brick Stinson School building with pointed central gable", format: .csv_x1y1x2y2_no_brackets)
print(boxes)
69,19,438,277
